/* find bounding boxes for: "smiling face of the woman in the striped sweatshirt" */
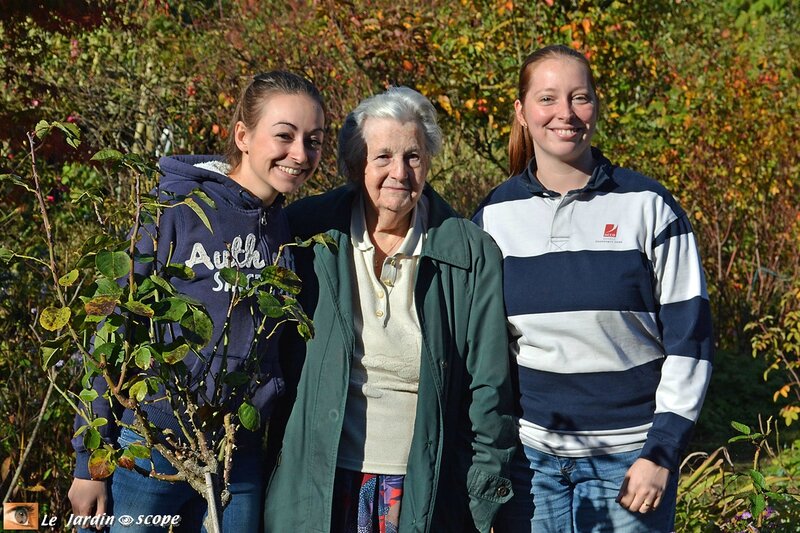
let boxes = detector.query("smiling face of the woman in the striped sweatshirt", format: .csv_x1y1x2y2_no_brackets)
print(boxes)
514,57,597,167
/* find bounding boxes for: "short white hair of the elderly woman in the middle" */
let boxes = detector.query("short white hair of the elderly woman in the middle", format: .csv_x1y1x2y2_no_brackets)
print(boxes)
337,87,442,183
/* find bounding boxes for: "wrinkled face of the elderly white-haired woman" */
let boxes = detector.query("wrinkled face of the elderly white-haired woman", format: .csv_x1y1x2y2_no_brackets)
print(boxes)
363,118,429,222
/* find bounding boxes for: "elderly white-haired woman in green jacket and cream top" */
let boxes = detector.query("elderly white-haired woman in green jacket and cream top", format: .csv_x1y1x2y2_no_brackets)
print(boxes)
264,87,515,533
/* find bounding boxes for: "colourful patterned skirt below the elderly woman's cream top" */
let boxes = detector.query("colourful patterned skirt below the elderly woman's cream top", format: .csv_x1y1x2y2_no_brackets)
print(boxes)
331,468,405,533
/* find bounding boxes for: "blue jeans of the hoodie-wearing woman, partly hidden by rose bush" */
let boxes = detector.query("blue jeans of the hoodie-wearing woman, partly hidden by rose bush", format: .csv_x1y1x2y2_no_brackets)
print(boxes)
83,428,266,533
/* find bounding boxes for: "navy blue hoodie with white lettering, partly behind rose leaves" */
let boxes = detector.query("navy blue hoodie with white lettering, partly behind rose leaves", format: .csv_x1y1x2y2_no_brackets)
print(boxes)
72,155,294,479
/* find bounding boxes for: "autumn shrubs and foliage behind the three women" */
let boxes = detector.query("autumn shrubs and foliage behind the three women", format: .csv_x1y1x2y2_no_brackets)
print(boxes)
0,0,800,531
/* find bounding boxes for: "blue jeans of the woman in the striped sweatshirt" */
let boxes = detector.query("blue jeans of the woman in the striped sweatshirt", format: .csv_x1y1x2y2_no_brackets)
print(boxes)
494,446,678,533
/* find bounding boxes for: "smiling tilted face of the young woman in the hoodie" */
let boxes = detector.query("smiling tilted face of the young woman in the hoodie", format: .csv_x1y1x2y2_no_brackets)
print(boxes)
230,93,325,205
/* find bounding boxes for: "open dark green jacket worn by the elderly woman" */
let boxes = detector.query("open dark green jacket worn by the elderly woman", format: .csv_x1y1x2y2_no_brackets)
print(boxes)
264,185,516,533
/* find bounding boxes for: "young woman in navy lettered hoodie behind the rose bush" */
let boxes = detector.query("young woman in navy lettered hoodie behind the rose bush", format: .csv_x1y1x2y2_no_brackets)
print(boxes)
69,71,325,532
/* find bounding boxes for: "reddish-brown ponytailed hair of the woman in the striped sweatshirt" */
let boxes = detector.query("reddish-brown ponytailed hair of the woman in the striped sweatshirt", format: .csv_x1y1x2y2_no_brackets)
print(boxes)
508,44,597,176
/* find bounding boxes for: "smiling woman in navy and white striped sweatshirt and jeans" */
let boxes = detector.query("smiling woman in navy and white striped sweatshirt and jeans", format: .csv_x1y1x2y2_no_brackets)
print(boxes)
474,46,713,533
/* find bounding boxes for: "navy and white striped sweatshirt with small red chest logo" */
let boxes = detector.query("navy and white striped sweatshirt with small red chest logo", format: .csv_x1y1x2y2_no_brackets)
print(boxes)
474,149,714,471
